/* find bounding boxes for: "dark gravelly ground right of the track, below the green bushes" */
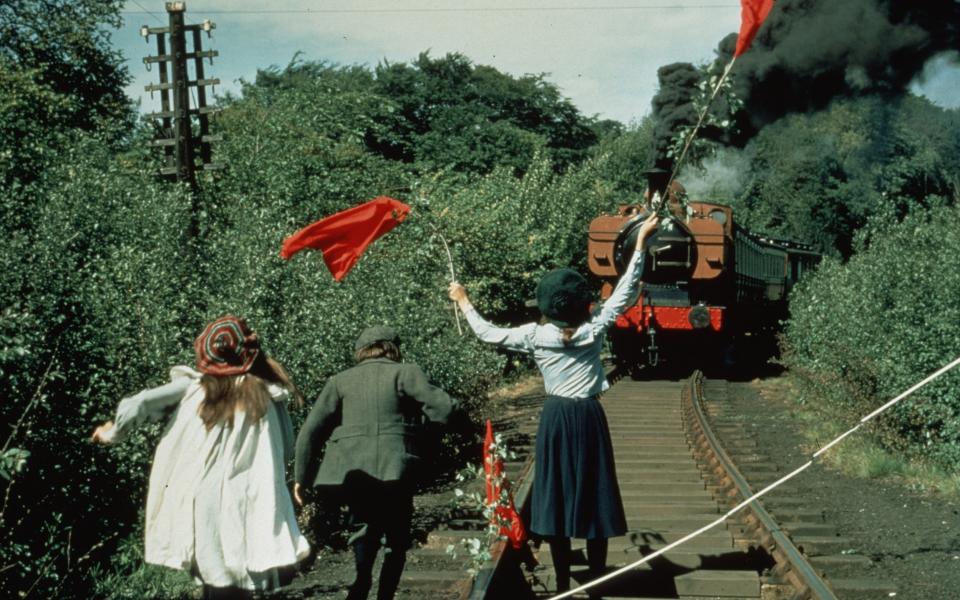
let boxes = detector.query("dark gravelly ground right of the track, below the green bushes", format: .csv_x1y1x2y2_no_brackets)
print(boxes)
704,376,960,600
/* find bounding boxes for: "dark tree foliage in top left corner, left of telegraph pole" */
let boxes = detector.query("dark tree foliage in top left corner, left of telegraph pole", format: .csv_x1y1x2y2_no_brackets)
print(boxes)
0,0,129,183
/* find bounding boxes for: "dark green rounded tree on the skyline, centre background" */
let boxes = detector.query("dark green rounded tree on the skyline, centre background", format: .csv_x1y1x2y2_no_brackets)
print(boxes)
374,53,597,173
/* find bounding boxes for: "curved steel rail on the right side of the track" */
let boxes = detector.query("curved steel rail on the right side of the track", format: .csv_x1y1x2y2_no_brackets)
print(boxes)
684,371,837,600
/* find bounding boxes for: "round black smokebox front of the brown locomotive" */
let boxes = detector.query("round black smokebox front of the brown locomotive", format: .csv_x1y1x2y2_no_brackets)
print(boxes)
613,214,697,284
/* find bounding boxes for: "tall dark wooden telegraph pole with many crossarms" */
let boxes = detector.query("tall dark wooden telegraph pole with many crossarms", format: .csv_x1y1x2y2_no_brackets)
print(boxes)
140,2,222,192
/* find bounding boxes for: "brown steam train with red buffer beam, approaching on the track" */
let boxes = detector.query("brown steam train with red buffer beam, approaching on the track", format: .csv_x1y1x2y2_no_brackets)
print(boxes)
587,182,820,369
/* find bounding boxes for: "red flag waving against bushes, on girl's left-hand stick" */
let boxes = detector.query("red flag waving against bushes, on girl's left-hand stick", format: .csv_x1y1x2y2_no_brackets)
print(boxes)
280,196,410,281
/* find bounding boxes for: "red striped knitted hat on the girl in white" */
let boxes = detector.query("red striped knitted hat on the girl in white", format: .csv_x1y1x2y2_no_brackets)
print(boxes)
193,315,260,375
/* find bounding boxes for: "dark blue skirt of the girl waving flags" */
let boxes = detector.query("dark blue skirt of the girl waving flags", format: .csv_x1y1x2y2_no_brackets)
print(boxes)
530,396,627,539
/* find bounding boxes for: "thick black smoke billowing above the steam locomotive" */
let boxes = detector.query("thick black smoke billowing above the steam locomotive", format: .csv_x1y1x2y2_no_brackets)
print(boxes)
653,0,960,165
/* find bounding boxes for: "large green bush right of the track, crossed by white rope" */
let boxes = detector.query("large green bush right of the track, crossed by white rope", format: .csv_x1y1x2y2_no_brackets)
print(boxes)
786,206,960,470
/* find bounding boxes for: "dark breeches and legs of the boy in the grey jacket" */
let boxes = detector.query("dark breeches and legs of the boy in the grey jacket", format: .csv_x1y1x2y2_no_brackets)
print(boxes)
342,474,413,600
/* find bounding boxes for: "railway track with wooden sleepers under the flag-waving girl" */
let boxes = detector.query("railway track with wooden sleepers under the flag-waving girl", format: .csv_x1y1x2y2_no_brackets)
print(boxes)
320,373,895,600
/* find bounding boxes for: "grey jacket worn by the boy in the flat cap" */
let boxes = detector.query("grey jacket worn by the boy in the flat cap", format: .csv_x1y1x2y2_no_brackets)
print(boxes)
295,358,454,486
